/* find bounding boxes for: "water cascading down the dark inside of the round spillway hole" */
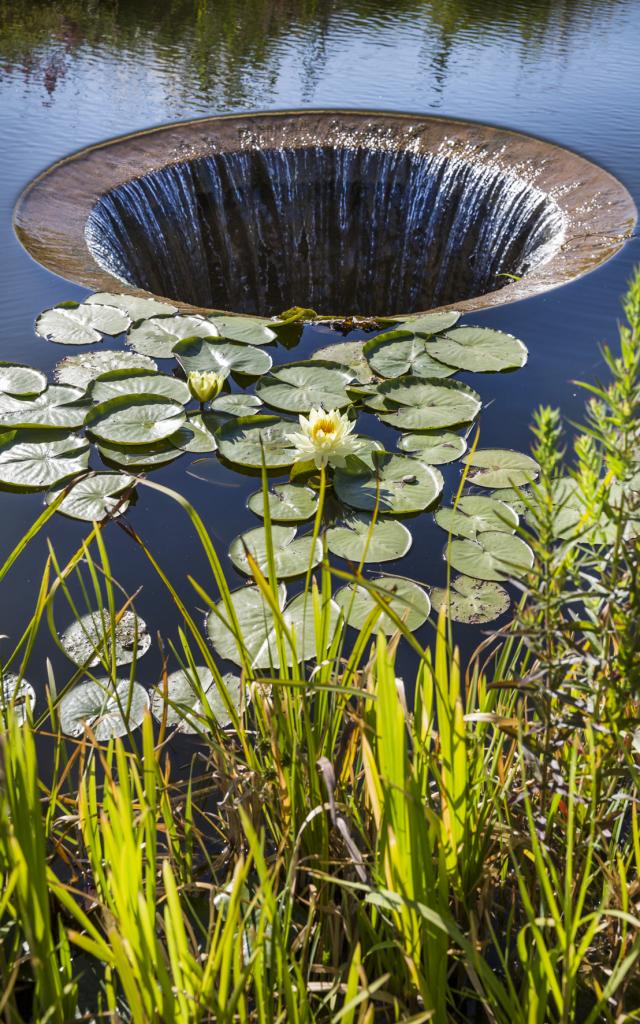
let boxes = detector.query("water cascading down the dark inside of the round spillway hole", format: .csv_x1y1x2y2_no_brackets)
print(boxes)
85,144,564,315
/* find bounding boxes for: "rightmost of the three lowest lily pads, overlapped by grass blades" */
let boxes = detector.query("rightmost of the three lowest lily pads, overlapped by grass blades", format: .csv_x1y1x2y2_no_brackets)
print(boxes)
152,665,242,732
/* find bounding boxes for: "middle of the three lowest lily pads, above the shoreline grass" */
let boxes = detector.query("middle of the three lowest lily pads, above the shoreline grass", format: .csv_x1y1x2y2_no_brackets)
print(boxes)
57,679,148,742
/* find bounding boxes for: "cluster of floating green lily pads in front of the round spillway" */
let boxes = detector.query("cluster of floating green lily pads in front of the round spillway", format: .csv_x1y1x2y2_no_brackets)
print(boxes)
0,293,538,738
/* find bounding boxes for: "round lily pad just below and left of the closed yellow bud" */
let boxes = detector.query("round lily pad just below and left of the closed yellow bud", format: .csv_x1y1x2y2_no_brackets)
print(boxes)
85,394,186,445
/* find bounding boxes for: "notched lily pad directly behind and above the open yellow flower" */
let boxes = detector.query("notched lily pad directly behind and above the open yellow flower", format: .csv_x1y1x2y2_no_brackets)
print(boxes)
256,359,351,413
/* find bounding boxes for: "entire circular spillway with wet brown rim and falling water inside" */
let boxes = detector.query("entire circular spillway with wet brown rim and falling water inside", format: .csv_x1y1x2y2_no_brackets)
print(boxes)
15,111,636,315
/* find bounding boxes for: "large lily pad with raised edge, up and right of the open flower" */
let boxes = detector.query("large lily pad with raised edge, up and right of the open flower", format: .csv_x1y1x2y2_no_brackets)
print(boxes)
365,377,482,430
